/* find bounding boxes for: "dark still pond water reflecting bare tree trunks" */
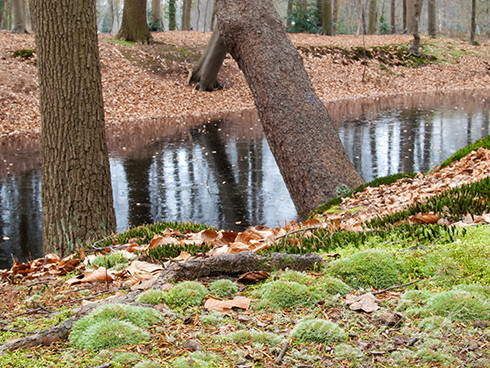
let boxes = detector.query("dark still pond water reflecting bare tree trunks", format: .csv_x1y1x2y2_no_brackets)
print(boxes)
0,91,490,268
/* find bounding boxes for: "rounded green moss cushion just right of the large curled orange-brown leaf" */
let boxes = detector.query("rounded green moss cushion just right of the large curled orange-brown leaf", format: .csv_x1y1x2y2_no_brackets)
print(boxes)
260,280,319,308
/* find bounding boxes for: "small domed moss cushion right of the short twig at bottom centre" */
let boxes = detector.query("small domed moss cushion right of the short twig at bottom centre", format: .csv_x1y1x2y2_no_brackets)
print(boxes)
292,318,347,344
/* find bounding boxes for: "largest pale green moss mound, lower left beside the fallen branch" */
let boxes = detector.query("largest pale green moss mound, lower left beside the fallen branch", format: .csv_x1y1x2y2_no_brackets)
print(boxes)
70,304,162,350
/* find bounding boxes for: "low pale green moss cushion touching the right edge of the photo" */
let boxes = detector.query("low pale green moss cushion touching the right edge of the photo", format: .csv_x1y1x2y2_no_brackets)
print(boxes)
427,290,490,321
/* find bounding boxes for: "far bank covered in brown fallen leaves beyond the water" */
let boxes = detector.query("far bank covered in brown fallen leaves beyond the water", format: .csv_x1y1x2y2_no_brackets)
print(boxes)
0,31,490,139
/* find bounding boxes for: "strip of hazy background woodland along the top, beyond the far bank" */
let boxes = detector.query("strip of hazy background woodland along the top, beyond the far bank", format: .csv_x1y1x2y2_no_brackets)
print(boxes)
0,0,490,37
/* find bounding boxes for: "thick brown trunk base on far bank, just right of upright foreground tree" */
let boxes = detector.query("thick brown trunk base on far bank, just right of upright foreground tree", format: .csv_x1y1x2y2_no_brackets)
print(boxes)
116,0,152,43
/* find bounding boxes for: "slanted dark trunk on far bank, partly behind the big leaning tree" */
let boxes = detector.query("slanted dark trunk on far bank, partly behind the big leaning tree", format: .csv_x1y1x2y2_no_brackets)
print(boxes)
188,27,227,91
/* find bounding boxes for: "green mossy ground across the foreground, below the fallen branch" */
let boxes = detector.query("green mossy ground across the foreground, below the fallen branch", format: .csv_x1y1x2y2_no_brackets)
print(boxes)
0,142,490,368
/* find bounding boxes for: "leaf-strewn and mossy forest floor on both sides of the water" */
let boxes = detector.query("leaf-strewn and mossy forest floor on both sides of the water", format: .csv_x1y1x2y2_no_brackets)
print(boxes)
0,31,490,368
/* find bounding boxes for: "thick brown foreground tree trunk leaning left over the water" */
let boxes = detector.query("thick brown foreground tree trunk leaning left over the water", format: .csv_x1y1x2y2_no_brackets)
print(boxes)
215,0,362,219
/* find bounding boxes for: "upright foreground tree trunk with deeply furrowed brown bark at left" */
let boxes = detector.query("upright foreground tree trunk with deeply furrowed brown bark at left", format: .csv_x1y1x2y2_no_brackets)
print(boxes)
31,0,116,255
